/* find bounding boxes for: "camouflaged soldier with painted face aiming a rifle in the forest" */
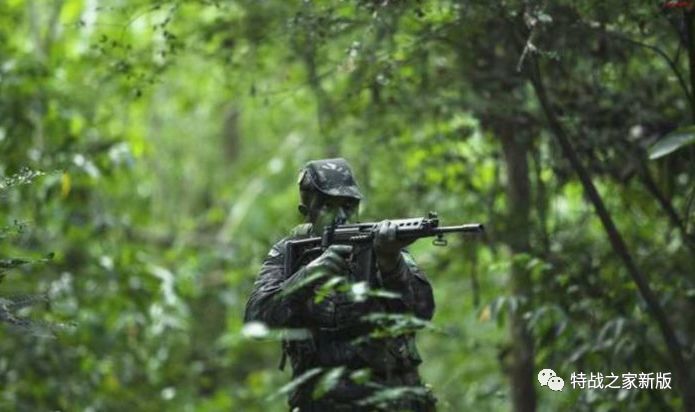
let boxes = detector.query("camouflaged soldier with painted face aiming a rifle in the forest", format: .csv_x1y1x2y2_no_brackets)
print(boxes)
245,158,435,412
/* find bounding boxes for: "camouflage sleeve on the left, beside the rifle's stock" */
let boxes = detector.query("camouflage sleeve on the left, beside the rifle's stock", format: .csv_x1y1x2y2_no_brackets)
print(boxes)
244,241,299,327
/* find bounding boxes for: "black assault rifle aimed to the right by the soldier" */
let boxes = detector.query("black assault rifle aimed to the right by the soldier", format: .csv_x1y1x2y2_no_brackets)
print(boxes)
284,212,485,286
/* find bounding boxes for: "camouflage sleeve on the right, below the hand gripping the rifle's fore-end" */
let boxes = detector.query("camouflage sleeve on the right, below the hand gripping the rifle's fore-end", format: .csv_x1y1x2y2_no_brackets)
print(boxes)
382,251,435,320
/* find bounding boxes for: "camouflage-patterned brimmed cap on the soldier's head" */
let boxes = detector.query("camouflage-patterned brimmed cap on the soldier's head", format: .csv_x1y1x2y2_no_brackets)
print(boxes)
297,157,362,200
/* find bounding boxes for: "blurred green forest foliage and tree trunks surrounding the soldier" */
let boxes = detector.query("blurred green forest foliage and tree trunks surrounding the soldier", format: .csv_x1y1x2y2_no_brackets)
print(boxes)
0,0,695,411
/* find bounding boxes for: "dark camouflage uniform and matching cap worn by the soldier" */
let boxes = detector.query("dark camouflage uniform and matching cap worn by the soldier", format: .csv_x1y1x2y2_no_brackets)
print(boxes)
245,159,435,412
